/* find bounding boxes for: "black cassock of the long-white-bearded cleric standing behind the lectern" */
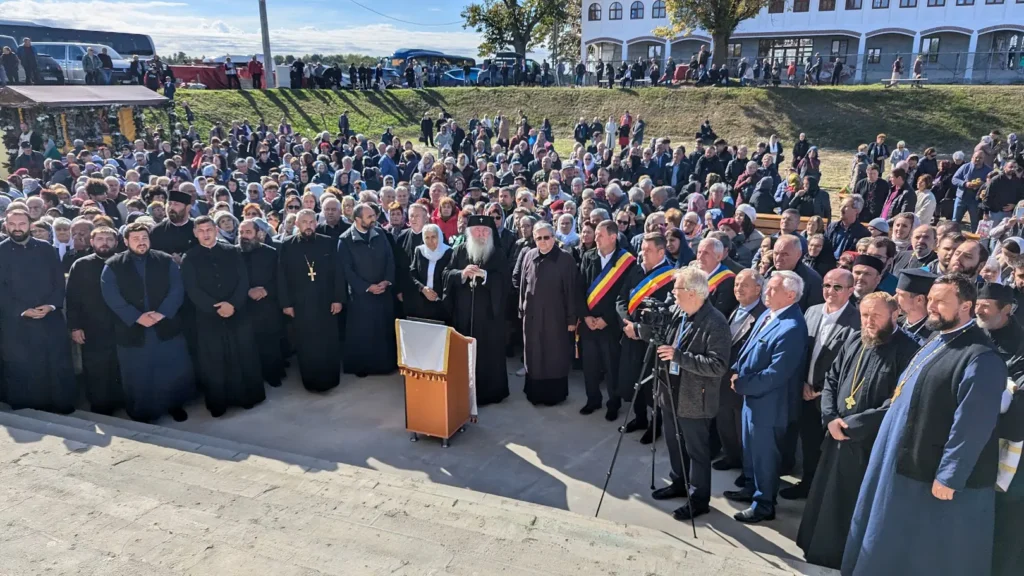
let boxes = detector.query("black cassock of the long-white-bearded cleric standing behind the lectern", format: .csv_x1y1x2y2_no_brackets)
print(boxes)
443,244,511,406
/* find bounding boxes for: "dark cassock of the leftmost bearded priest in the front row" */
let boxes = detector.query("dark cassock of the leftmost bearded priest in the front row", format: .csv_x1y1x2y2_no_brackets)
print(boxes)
0,238,78,414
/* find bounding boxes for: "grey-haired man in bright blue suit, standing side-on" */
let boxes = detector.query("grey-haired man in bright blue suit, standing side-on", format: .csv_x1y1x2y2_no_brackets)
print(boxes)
725,271,807,524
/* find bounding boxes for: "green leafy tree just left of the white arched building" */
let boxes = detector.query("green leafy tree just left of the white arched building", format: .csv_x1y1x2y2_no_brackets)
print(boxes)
462,0,566,56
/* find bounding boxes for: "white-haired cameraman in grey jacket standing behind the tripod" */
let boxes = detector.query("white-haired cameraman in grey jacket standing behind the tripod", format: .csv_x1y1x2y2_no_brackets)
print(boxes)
651,266,731,522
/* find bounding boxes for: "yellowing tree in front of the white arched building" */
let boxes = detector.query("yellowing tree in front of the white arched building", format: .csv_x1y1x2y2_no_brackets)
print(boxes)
654,0,769,65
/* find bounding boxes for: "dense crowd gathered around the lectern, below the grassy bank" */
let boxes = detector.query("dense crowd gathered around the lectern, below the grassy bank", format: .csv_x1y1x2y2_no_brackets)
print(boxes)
0,104,1024,576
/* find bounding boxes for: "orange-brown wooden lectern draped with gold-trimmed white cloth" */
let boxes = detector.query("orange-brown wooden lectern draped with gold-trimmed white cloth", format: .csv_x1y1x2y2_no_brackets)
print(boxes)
395,320,476,448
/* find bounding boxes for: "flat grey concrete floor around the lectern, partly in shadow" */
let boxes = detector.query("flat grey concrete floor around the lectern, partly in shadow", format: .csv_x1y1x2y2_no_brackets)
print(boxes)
160,362,803,560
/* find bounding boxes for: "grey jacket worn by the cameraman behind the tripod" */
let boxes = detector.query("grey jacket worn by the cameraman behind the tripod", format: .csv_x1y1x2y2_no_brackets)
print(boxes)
663,300,732,418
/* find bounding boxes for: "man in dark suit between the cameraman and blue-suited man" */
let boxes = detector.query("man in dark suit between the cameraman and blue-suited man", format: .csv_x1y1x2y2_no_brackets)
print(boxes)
712,269,767,471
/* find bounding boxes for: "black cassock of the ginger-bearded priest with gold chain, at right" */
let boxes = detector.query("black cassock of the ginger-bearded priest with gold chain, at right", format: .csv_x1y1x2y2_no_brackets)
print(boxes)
797,328,920,570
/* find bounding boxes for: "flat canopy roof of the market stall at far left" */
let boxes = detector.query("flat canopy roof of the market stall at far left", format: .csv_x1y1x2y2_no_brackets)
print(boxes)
0,86,168,108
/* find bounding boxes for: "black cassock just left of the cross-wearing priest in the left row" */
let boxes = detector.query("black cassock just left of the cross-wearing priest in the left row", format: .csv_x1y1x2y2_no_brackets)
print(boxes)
242,244,285,386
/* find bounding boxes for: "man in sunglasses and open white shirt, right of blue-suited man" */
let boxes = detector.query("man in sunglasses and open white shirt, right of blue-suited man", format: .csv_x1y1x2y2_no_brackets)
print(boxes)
779,269,860,500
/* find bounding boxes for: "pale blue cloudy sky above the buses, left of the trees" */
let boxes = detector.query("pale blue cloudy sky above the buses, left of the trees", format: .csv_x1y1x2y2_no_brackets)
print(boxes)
0,0,480,57
